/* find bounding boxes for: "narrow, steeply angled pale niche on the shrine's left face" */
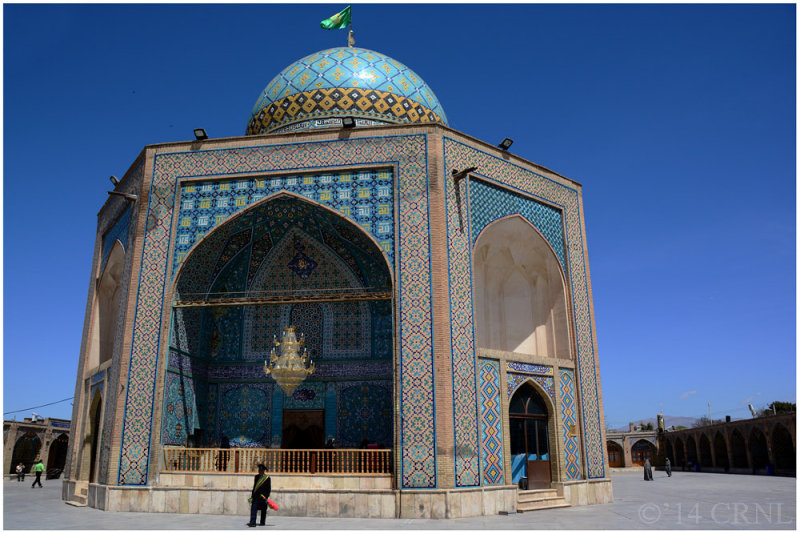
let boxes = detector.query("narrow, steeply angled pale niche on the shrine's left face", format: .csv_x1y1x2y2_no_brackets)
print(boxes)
84,240,125,373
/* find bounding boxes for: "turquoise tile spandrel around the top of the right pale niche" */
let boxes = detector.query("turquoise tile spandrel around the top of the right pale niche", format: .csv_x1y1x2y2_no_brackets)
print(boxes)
469,180,566,270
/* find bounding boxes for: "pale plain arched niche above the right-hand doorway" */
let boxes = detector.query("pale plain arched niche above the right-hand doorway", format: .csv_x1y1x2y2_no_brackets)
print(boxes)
473,215,573,359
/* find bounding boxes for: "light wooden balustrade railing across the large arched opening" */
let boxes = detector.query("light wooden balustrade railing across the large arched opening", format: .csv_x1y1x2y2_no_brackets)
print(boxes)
164,447,392,475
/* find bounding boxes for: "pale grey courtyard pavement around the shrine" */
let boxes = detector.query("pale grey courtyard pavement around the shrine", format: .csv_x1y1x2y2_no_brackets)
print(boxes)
3,470,797,532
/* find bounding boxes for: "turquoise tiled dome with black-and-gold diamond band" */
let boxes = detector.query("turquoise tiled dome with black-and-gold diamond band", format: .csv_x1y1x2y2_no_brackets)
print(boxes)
246,47,447,135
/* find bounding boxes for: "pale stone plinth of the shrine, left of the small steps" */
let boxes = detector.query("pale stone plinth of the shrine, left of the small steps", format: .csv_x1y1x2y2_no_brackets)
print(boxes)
62,474,517,519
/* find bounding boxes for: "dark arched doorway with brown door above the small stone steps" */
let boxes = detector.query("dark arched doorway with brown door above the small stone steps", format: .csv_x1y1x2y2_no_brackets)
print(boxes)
508,382,552,489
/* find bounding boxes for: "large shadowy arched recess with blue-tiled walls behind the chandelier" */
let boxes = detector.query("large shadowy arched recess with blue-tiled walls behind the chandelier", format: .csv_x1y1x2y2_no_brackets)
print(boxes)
166,193,394,456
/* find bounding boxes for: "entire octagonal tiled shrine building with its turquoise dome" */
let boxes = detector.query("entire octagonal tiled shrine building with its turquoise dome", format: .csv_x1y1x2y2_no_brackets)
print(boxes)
63,47,612,518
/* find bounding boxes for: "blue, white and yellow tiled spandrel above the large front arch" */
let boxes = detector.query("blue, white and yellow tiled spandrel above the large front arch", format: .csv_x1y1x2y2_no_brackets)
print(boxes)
172,168,394,276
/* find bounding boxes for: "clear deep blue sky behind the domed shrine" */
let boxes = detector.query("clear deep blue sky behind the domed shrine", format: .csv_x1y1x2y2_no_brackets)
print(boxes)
3,4,796,427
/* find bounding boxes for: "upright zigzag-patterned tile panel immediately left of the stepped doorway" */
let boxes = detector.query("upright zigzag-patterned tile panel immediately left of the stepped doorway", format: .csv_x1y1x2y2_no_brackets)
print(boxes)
478,360,503,485
